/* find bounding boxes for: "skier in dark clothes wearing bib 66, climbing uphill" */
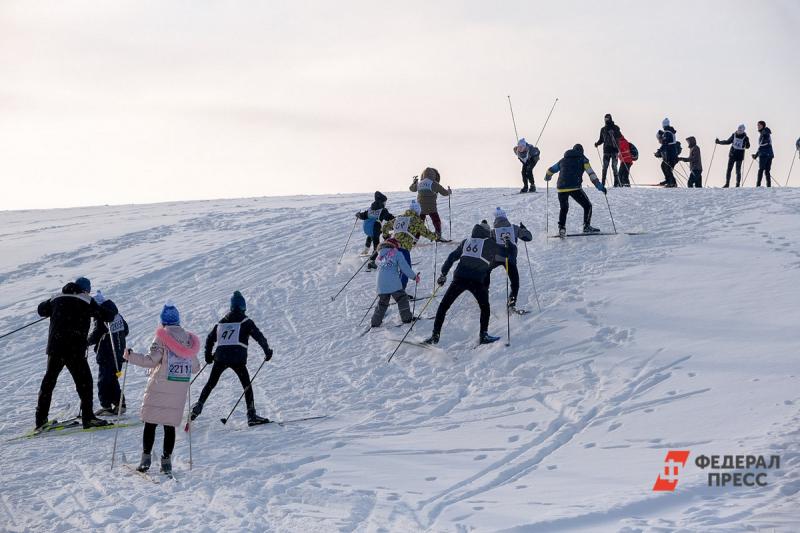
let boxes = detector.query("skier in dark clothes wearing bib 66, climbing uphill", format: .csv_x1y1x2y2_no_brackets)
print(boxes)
425,224,500,344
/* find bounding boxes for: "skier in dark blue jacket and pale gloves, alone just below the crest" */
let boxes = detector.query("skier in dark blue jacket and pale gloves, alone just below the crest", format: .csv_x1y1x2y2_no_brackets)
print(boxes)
544,144,607,238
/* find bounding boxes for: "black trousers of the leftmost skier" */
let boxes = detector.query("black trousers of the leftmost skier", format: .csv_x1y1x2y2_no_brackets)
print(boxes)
36,353,94,427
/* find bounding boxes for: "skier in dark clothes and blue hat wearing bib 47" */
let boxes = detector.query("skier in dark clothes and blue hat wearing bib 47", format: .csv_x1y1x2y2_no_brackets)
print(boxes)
191,291,272,426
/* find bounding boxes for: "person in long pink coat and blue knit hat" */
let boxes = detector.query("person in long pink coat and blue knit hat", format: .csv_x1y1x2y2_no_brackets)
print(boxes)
124,302,200,475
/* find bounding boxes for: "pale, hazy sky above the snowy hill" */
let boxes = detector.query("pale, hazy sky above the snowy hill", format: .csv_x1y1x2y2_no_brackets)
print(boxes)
0,0,800,209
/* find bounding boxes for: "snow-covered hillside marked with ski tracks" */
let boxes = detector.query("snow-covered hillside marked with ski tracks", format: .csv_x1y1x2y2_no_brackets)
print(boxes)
0,189,800,532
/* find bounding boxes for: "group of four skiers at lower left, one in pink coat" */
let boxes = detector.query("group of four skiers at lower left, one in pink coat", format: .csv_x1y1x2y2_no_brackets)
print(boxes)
35,277,273,475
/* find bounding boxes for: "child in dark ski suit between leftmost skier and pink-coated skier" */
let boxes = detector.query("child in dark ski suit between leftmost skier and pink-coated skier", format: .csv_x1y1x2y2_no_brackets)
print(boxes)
87,291,130,416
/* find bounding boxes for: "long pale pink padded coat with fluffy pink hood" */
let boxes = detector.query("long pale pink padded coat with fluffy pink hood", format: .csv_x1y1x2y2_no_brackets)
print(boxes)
126,326,200,426
